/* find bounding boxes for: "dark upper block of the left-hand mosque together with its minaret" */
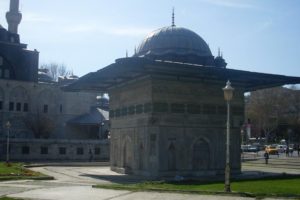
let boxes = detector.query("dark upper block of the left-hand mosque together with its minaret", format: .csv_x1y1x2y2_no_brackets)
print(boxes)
0,0,39,82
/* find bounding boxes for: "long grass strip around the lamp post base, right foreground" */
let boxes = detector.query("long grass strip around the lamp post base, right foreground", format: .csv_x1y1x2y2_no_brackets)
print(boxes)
95,176,300,198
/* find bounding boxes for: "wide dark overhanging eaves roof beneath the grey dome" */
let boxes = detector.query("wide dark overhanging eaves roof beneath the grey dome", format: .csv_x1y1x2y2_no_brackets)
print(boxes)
65,58,300,92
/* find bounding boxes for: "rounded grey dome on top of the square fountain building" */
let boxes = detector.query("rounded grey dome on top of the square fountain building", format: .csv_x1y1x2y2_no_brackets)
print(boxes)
134,26,213,64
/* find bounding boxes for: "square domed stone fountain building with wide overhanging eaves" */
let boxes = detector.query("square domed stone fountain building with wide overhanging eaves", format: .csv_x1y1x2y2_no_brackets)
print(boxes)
67,11,300,177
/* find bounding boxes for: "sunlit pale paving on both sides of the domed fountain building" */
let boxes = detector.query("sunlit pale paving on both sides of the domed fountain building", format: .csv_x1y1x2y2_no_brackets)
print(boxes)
0,154,300,200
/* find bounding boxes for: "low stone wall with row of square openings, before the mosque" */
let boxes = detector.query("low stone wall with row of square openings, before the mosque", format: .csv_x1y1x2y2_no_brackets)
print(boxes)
0,139,110,161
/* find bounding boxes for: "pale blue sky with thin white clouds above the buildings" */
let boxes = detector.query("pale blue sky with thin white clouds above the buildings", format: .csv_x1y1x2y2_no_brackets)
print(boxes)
0,0,300,76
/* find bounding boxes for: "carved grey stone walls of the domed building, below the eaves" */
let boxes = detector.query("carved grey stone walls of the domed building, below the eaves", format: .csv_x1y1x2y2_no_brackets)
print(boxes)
109,76,244,176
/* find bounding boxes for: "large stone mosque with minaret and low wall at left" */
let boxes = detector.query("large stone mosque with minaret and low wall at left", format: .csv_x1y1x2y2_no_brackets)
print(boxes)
0,0,109,161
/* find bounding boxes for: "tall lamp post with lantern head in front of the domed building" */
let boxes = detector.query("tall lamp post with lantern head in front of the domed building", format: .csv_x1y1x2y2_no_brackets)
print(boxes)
223,80,234,192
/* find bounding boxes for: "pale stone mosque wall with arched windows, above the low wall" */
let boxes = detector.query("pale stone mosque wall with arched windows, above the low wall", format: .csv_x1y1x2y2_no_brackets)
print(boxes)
0,79,97,139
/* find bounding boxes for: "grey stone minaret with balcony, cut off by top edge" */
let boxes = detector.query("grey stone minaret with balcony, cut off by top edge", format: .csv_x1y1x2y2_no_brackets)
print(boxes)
6,0,22,34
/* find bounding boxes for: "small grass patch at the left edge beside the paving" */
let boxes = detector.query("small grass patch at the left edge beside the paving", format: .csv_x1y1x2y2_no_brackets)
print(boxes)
0,162,51,181
